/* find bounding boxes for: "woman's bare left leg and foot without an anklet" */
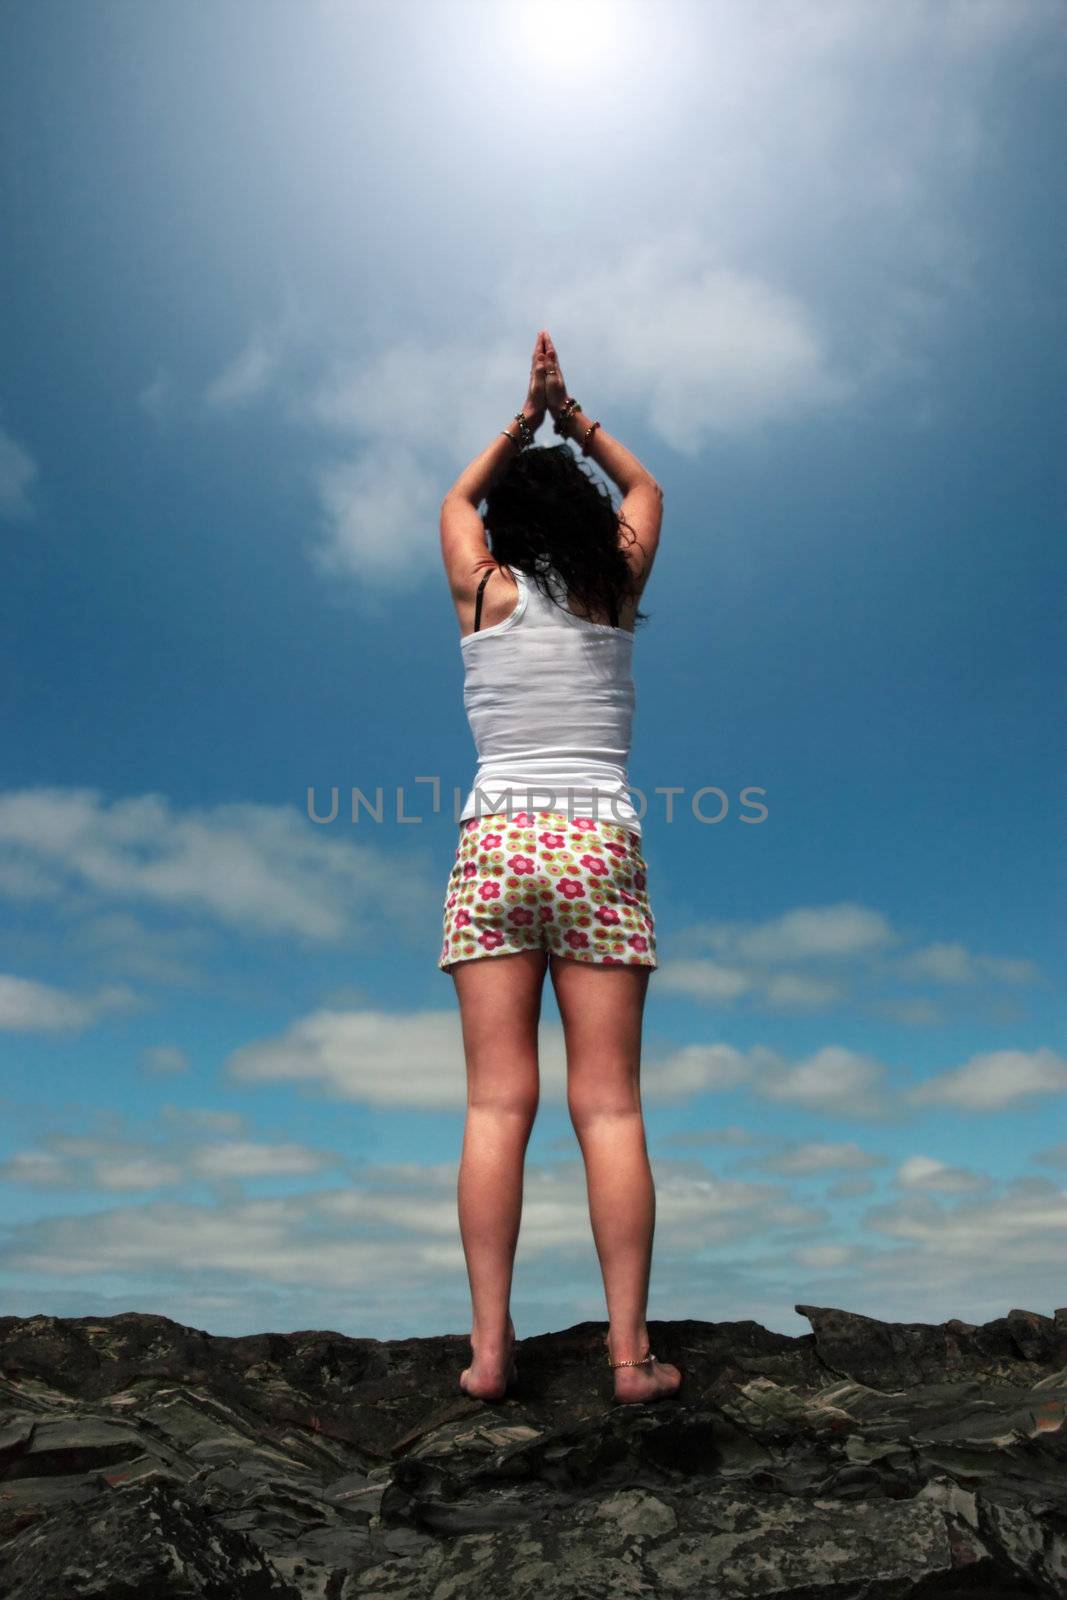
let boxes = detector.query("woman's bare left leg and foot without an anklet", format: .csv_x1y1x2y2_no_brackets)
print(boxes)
453,950,547,1400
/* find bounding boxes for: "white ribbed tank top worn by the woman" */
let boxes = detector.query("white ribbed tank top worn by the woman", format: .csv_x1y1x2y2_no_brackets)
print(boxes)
459,566,641,835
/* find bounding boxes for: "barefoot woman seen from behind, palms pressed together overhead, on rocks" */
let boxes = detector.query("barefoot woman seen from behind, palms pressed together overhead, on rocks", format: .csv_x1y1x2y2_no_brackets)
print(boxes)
438,331,681,1403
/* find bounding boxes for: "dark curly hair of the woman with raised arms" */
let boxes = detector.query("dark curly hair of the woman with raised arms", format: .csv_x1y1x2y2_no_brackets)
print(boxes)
482,445,648,627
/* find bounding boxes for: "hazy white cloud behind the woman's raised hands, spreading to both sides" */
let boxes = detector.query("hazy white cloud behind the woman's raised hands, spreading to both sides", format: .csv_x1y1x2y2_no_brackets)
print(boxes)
290,252,849,587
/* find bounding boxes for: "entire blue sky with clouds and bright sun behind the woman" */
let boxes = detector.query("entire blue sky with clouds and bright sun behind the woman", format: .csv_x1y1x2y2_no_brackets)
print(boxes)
0,0,1067,1338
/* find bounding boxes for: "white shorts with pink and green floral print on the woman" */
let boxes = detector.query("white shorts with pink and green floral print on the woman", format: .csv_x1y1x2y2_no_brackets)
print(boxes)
437,811,659,973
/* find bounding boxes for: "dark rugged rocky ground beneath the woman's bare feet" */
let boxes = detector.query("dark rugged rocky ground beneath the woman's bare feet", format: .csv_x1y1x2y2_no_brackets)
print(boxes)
0,1306,1067,1600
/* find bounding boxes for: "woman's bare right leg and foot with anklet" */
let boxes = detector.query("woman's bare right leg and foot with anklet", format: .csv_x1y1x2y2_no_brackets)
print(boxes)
550,955,681,1402
